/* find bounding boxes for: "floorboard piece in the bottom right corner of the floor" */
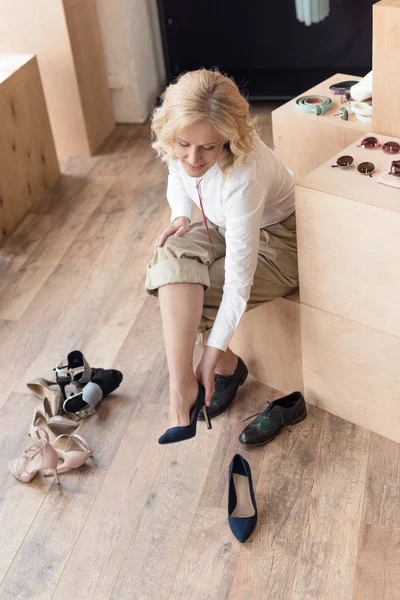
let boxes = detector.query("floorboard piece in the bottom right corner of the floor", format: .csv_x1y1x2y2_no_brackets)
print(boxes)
353,525,400,600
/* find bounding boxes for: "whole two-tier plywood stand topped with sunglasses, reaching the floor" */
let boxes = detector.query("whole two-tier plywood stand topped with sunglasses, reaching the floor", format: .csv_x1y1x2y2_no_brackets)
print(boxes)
296,134,400,442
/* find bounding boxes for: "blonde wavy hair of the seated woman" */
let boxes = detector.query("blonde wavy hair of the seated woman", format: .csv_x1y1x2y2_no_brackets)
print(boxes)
151,69,256,170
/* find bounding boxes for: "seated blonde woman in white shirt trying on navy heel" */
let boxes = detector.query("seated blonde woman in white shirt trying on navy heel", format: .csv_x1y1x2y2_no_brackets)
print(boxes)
146,69,298,443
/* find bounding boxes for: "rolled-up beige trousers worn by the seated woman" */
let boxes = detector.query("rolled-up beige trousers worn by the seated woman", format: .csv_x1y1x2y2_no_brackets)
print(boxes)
146,213,299,344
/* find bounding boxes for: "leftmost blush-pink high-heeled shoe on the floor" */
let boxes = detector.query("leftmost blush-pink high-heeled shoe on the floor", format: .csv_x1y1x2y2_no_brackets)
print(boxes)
8,427,60,484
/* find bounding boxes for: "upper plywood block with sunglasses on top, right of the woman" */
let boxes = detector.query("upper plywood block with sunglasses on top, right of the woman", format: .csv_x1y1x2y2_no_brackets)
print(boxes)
296,134,400,337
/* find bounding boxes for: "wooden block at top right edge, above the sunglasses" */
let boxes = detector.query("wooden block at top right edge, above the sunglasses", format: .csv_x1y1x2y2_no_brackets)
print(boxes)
372,0,400,137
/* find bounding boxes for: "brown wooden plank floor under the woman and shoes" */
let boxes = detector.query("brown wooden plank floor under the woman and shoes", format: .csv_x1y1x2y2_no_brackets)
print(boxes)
0,111,400,600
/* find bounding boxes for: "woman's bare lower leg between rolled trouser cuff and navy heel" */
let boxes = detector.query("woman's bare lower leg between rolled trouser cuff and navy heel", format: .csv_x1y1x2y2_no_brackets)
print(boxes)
158,283,204,427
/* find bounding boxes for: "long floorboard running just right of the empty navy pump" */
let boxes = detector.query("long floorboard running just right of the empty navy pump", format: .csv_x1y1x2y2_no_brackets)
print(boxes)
229,407,327,600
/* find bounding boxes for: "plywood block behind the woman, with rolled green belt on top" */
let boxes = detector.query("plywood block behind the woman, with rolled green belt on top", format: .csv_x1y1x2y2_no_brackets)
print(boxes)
272,73,371,180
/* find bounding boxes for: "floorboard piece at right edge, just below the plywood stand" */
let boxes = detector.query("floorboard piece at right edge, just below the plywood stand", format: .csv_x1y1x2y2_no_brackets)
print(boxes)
363,433,400,528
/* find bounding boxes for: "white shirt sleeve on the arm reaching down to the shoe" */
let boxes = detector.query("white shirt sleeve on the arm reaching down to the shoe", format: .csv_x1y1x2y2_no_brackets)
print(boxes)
207,173,265,351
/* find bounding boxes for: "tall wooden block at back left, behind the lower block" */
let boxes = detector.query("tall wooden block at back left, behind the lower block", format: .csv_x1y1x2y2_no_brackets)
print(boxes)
0,0,115,157
